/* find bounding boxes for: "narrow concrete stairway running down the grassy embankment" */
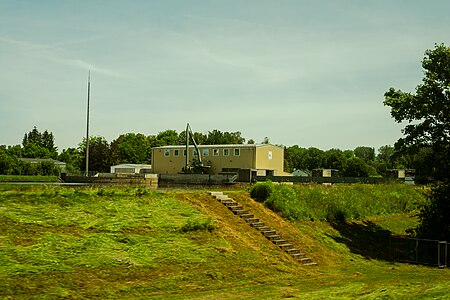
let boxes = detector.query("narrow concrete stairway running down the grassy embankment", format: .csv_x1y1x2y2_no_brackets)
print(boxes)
209,192,317,266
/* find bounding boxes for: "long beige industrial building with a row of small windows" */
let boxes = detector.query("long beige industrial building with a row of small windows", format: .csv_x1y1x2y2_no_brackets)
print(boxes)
152,144,284,175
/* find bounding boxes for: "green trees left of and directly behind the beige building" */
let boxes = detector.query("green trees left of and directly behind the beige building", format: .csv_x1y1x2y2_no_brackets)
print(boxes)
0,127,248,175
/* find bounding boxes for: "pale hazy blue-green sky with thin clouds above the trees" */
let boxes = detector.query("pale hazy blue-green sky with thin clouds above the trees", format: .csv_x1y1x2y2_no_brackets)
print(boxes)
0,0,450,151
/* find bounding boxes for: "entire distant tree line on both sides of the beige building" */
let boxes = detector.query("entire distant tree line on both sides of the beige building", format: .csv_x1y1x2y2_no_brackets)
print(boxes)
0,127,427,177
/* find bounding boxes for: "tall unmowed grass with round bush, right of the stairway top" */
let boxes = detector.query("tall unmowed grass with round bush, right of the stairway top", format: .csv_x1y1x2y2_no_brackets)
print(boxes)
250,182,425,221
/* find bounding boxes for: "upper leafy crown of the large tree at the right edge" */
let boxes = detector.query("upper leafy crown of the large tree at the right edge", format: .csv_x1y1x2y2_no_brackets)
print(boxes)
384,44,450,180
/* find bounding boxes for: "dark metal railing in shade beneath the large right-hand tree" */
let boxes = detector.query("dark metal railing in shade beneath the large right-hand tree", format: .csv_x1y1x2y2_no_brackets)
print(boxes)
389,237,448,268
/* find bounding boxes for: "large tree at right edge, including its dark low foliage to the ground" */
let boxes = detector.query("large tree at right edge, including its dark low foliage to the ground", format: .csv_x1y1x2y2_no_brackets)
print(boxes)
384,44,450,240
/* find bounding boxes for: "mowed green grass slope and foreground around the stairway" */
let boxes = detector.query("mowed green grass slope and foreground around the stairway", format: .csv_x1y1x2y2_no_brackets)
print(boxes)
0,187,450,299
